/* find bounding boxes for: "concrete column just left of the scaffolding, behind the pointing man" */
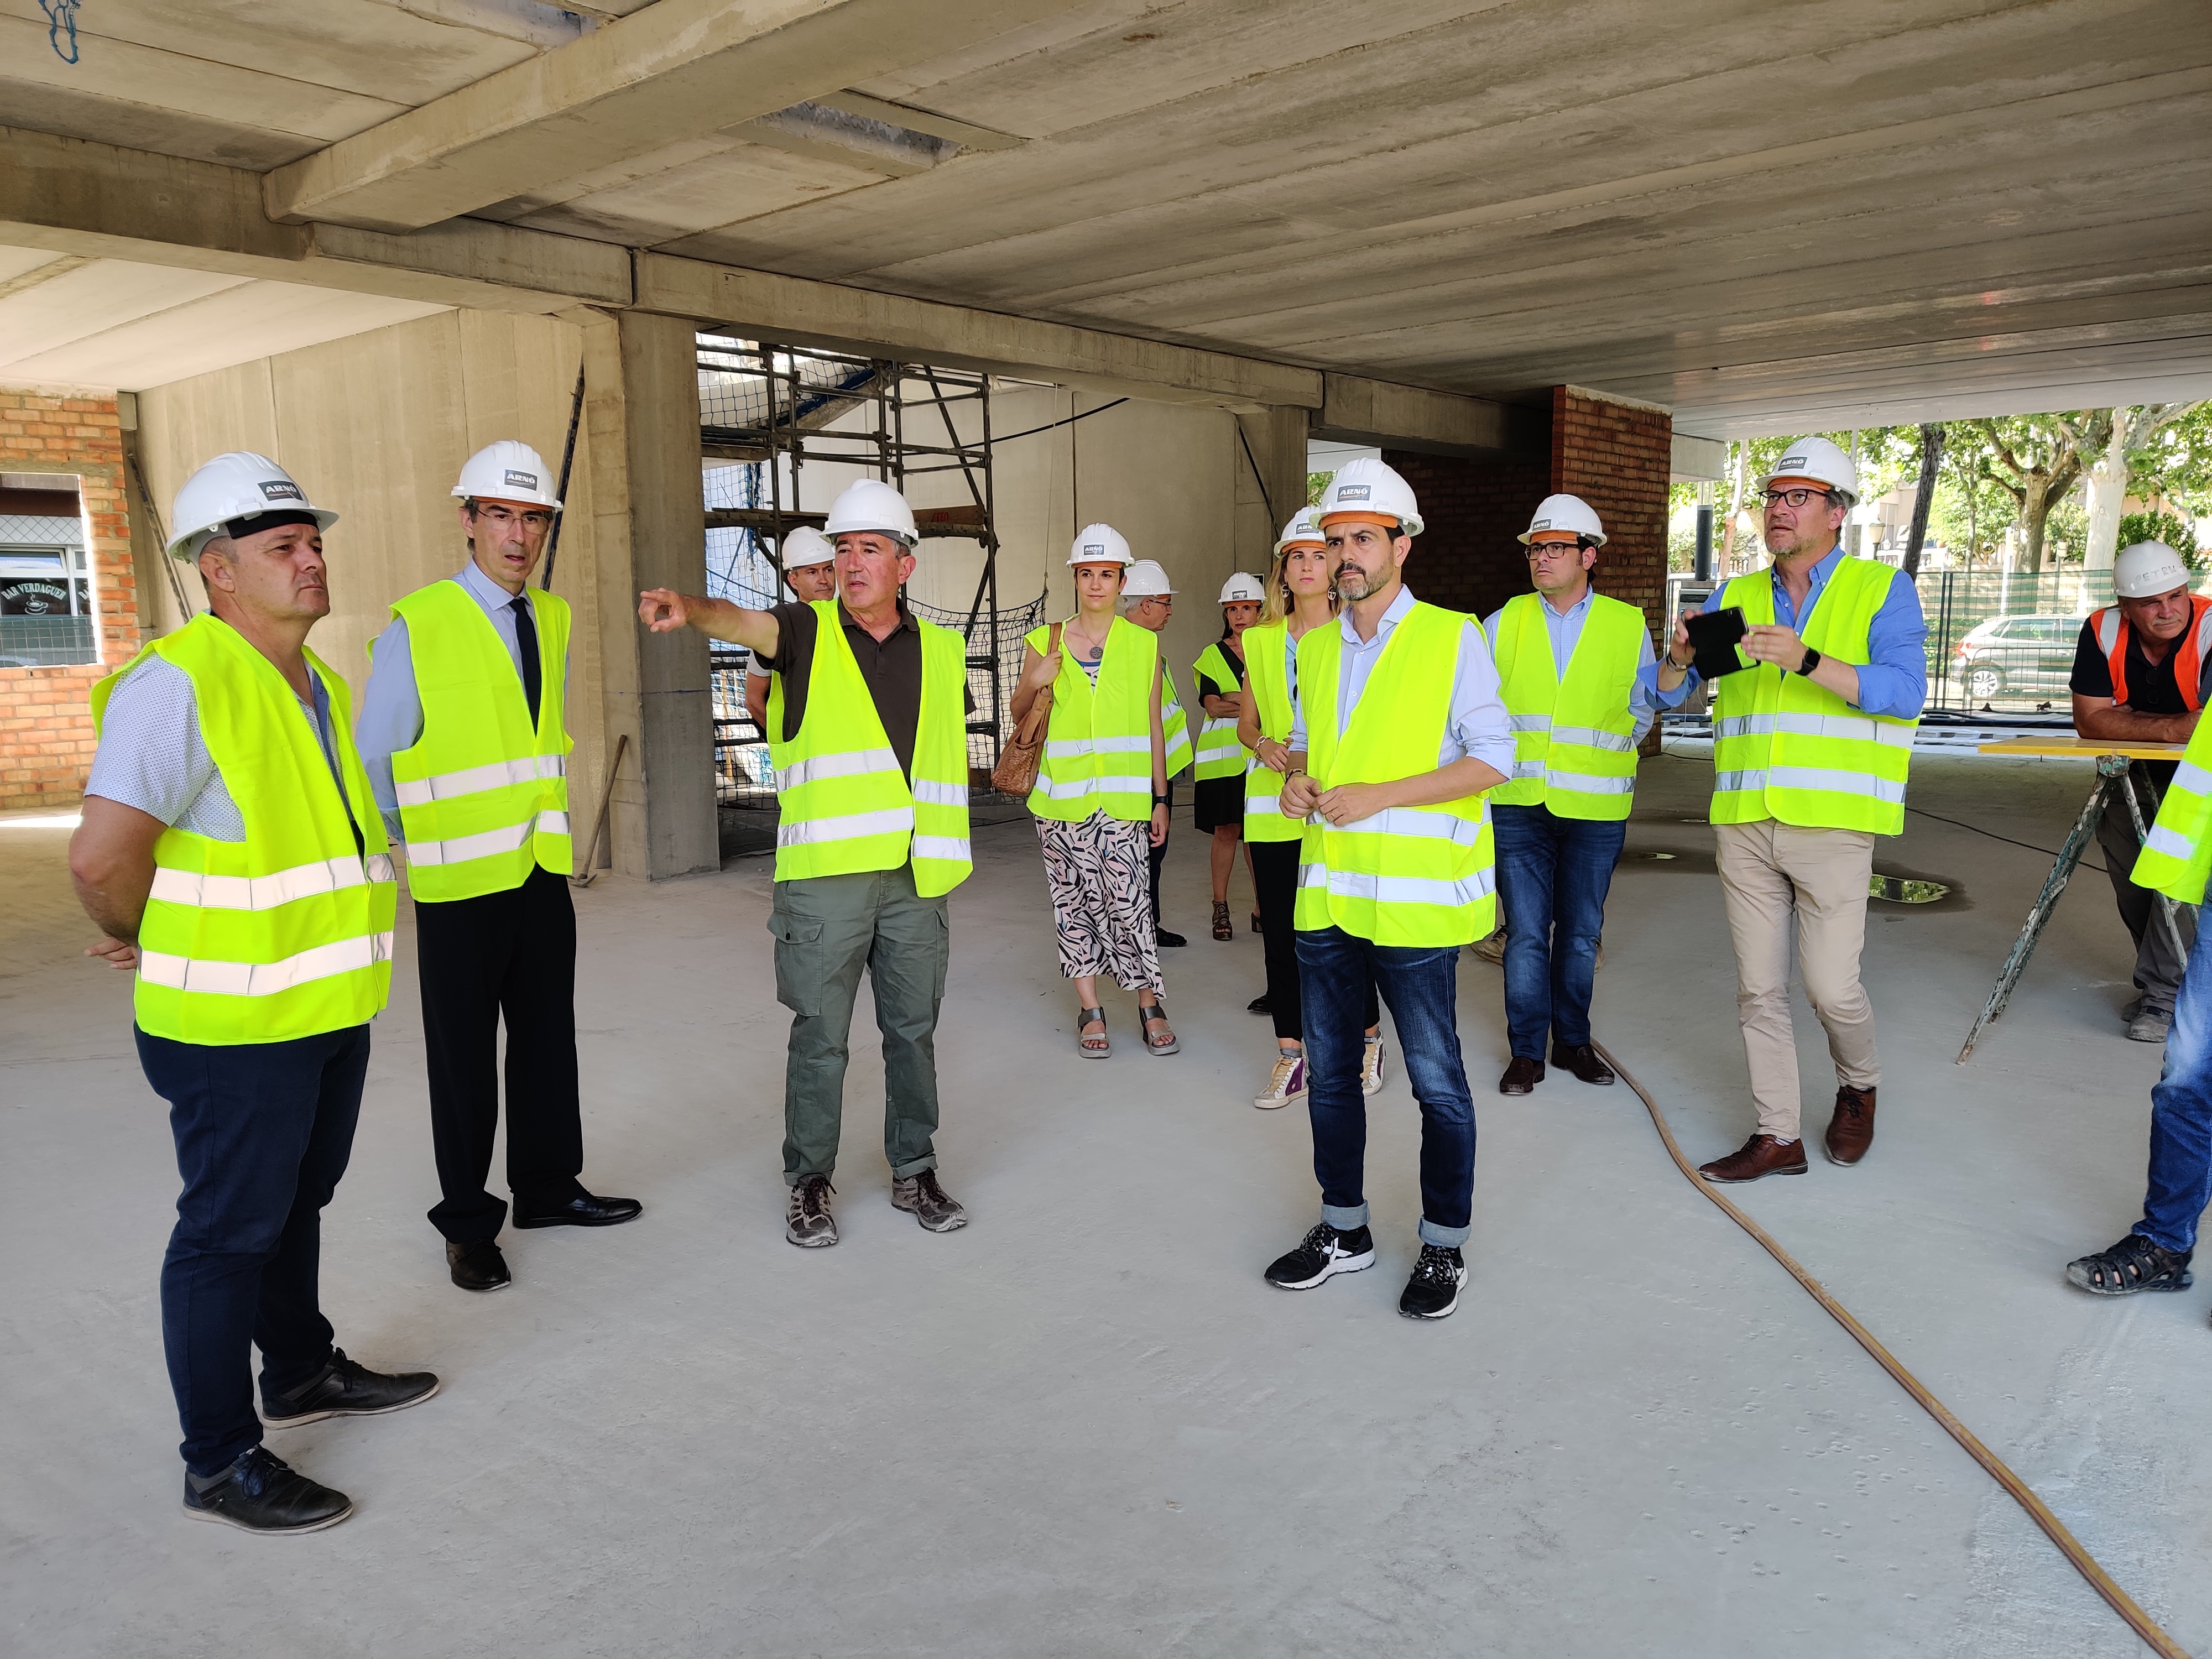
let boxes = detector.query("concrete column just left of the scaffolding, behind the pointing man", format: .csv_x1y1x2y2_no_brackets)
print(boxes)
571,312,721,878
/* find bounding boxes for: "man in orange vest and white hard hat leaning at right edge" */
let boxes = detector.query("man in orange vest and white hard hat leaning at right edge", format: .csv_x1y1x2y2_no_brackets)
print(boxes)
2068,542,2212,1042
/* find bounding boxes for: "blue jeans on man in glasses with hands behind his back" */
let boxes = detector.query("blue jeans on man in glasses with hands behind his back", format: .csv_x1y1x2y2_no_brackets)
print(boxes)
1491,805,1628,1062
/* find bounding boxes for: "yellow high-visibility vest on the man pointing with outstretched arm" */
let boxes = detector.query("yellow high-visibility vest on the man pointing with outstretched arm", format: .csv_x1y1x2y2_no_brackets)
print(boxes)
768,599,973,898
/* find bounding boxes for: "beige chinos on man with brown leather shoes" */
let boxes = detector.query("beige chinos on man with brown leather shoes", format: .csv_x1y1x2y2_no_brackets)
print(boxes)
1712,818,1882,1141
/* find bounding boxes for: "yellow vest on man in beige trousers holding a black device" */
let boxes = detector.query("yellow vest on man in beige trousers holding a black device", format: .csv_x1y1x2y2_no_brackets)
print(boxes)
1710,560,1920,836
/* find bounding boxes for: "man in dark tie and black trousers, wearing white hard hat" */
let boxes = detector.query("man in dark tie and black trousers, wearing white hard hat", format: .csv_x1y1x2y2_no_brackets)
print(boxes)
361,438,644,1292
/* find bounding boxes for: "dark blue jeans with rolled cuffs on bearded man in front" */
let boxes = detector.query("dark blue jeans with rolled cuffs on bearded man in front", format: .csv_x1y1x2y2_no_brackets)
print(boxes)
1298,927,1475,1248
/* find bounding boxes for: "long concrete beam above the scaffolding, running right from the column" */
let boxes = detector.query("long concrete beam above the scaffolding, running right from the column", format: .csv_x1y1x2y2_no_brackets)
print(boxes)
630,250,1310,411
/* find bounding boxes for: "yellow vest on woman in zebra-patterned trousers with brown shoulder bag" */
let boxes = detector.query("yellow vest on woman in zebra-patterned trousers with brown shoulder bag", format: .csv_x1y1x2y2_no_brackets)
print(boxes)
1029,617,1159,823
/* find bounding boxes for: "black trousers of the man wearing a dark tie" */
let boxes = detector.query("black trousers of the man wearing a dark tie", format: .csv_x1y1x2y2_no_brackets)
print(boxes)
416,869,584,1243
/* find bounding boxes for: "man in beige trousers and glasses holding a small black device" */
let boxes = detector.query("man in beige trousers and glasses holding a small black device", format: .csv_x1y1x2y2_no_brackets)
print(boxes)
1646,438,1927,1181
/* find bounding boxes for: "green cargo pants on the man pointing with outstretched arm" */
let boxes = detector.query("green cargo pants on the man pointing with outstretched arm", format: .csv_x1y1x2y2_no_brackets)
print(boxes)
768,865,951,1186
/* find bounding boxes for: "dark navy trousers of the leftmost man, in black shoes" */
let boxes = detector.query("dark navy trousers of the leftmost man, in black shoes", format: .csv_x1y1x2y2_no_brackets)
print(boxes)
137,1026,369,1475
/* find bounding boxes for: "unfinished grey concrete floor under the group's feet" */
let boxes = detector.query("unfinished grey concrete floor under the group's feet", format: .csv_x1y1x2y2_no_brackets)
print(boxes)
0,759,2212,1659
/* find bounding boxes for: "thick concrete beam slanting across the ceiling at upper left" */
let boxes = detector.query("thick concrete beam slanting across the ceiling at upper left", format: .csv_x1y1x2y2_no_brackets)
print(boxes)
265,0,1093,232
